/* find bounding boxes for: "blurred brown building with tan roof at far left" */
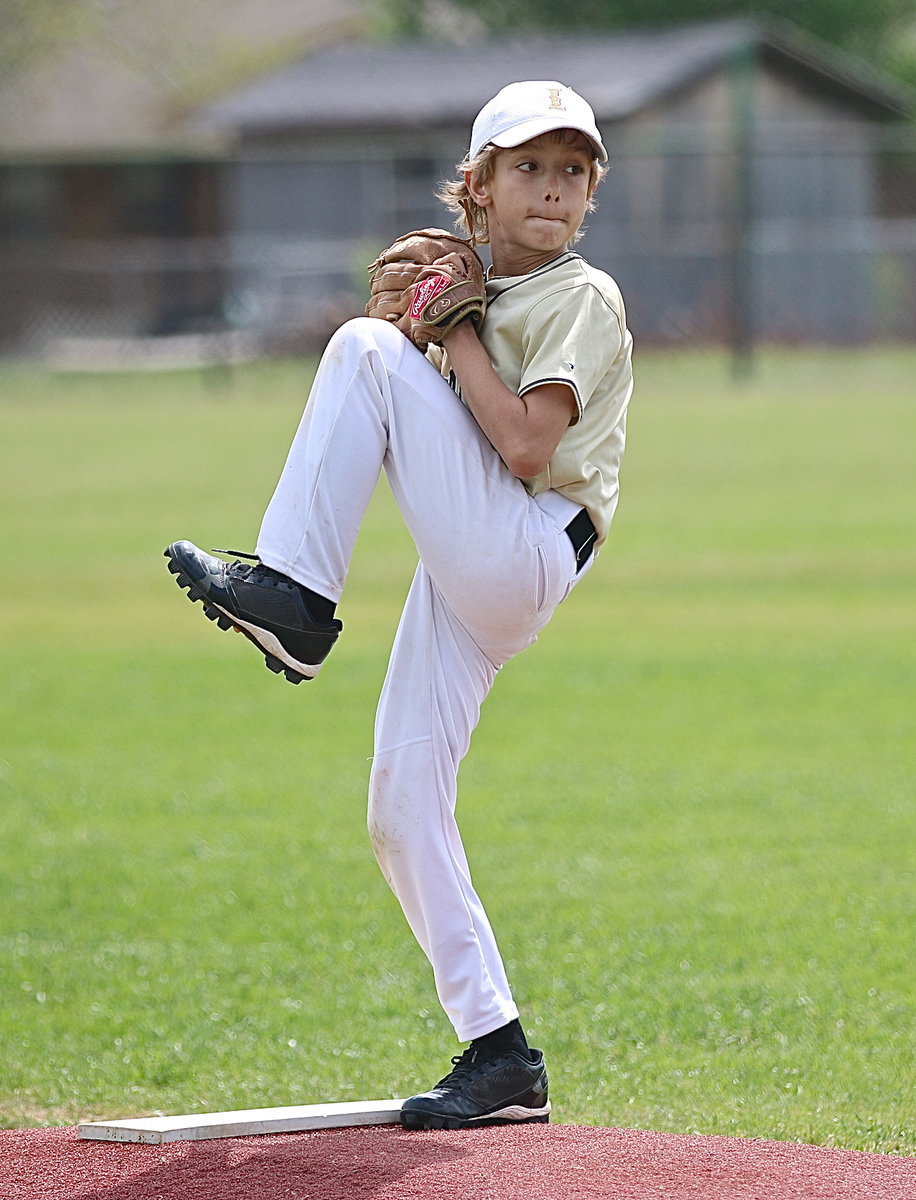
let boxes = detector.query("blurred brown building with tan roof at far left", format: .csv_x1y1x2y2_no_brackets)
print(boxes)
0,0,369,356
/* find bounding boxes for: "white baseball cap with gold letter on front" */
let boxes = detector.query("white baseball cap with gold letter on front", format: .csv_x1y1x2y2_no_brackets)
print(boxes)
471,79,607,163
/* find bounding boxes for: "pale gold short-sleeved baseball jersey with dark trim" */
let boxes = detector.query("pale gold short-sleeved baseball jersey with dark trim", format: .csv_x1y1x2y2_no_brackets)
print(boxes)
443,251,633,546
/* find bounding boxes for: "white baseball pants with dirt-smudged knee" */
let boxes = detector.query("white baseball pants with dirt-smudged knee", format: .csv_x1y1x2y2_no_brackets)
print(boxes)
257,317,588,1042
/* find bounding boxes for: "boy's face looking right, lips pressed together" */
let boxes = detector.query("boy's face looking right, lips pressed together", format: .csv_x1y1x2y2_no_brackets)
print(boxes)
469,130,594,274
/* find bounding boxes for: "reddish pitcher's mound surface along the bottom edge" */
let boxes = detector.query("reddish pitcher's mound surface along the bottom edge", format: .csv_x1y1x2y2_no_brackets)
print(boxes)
0,1124,916,1200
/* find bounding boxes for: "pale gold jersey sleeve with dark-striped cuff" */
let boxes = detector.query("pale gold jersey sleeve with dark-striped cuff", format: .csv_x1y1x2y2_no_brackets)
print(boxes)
519,283,623,420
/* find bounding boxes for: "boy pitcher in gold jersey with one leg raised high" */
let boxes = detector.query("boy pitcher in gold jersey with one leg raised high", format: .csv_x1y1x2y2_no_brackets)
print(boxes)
166,82,633,1129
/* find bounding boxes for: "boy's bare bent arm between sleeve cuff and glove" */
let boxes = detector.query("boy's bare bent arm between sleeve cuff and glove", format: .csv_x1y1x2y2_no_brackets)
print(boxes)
443,320,576,479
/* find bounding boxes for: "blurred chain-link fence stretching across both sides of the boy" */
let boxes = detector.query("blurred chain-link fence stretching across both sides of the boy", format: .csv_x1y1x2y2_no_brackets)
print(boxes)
0,127,916,370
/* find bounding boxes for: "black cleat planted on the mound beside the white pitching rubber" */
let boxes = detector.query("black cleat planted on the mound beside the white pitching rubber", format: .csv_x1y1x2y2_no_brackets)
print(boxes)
401,1045,550,1129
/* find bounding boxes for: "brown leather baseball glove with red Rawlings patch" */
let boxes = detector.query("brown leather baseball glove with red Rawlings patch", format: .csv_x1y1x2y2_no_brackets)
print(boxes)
366,229,486,350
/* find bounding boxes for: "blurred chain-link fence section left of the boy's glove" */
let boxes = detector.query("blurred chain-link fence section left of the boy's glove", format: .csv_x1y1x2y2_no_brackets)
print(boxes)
0,238,366,368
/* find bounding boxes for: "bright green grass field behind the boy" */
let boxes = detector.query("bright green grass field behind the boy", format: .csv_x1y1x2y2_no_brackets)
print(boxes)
0,349,916,1153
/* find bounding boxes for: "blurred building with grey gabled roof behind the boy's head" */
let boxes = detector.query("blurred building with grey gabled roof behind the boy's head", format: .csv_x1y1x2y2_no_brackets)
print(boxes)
3,19,916,348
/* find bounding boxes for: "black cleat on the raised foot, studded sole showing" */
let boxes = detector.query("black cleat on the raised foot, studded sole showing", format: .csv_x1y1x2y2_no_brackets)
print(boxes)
164,541,343,683
